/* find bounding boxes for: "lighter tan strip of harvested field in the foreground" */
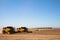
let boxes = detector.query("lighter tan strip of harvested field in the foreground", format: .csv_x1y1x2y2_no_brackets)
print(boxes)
0,34,60,40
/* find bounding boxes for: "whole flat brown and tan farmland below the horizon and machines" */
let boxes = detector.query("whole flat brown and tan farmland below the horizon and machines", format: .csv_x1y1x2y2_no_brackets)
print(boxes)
0,29,60,40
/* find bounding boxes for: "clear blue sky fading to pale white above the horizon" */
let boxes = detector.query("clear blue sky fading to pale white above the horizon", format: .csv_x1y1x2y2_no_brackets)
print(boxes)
0,0,60,27
